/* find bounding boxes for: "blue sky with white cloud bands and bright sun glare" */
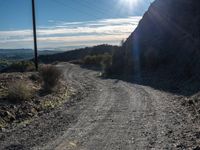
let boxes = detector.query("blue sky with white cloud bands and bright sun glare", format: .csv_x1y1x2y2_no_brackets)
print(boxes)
0,0,152,50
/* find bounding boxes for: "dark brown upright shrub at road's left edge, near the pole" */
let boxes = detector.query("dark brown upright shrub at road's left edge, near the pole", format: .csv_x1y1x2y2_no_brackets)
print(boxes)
39,65,62,92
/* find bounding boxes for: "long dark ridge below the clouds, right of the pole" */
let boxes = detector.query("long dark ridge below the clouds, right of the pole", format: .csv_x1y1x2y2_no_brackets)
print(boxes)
39,45,119,63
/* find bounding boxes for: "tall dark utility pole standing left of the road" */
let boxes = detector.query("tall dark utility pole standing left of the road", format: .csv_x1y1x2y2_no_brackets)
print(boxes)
32,0,38,71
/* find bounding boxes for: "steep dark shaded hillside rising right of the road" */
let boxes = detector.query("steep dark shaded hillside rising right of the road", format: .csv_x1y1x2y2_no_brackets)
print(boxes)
113,0,200,77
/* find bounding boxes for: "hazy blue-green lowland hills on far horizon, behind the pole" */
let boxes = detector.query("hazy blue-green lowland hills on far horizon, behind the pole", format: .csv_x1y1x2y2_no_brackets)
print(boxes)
0,49,59,60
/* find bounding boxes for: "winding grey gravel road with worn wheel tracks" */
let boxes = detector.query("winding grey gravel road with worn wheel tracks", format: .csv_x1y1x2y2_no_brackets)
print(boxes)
0,63,200,150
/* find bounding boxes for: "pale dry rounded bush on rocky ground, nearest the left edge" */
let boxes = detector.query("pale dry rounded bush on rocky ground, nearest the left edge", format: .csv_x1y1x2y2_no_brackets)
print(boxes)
8,81,33,102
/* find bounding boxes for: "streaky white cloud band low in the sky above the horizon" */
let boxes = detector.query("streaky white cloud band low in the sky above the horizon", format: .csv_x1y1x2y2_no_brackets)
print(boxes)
0,16,141,49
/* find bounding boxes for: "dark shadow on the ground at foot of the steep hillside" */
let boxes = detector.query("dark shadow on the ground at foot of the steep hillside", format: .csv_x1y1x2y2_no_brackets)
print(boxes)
102,73,200,96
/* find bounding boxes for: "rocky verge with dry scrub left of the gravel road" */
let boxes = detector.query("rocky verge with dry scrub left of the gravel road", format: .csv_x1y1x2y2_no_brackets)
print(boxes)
0,70,71,130
